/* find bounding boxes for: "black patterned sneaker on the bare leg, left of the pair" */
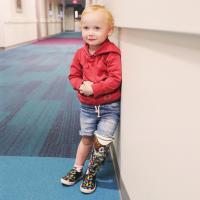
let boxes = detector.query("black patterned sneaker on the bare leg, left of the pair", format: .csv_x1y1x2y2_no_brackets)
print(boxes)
60,168,83,185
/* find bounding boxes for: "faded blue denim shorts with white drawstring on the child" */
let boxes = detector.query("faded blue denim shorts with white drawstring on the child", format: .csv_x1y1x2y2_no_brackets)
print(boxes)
80,101,120,139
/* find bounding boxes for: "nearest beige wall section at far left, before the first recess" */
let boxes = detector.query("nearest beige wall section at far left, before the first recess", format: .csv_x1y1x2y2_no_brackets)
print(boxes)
0,0,37,47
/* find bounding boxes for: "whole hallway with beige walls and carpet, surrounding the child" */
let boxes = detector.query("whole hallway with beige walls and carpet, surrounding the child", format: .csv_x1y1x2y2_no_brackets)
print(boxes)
0,0,200,200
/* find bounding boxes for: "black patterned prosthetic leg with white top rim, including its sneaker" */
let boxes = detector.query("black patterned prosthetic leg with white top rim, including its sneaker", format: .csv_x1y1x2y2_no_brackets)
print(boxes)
80,133,113,193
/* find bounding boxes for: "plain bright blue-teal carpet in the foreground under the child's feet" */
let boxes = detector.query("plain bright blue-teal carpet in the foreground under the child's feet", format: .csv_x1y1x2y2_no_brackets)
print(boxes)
0,156,119,200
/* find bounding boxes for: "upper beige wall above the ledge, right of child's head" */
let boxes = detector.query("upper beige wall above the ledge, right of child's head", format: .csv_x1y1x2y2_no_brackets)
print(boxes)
107,0,200,34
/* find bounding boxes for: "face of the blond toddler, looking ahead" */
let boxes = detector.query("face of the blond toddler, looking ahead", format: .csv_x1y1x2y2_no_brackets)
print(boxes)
81,11,112,49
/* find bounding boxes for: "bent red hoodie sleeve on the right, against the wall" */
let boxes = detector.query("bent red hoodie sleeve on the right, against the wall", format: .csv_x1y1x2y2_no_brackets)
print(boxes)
92,53,122,97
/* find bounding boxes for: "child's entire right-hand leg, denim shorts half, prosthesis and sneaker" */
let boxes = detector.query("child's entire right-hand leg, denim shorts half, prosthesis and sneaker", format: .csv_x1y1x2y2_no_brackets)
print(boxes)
80,102,120,193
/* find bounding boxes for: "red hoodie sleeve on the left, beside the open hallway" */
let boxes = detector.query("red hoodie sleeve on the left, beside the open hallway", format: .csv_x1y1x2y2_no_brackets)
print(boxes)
68,50,83,90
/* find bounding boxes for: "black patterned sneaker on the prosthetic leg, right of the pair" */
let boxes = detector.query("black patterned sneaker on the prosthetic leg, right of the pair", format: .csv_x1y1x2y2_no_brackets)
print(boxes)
80,173,96,194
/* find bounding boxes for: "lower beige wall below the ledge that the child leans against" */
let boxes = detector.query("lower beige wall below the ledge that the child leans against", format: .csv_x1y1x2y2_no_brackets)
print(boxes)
119,28,200,200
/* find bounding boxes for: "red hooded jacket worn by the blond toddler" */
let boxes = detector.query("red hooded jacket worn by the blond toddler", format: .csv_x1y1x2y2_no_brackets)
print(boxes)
69,39,122,105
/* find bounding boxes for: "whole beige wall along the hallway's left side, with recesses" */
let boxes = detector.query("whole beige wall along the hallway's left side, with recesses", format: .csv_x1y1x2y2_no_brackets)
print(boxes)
0,0,62,48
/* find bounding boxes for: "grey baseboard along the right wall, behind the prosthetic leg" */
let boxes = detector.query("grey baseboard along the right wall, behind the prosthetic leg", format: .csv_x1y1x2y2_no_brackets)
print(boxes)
111,145,131,200
